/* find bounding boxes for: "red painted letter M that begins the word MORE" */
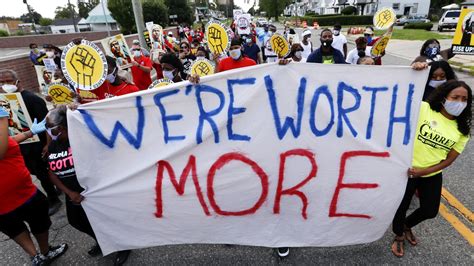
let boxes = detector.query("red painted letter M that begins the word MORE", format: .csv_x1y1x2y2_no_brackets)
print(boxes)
155,155,211,218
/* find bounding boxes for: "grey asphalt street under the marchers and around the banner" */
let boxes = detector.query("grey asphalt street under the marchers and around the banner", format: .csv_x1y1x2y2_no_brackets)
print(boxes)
0,24,474,265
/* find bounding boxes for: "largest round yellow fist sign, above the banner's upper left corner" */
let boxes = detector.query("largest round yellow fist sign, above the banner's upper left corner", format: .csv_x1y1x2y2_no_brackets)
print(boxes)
61,40,107,90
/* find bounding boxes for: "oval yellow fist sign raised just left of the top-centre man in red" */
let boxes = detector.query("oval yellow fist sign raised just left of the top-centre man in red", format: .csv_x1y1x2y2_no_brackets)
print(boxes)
206,21,231,54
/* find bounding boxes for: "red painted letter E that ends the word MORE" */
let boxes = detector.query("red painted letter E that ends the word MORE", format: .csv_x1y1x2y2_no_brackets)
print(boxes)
329,151,390,219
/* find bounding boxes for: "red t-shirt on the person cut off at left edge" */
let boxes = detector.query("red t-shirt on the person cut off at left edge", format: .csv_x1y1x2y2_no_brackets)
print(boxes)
0,137,36,215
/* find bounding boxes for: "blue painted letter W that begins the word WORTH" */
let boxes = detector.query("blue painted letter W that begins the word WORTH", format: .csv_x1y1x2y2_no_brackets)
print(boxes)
265,75,306,139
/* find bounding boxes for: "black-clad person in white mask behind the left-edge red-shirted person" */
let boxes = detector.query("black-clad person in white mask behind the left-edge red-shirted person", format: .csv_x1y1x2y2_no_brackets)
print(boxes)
0,69,61,215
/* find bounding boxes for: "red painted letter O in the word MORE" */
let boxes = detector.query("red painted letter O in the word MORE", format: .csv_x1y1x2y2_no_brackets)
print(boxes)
207,152,268,216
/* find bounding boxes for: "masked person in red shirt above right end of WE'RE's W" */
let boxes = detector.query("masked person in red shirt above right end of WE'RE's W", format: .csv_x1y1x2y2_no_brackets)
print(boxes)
131,46,152,90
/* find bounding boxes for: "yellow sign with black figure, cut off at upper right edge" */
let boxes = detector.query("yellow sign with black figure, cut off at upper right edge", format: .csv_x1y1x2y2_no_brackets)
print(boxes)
452,8,474,54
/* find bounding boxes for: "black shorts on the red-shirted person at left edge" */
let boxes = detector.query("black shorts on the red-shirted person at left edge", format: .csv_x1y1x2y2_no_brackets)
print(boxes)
0,190,51,238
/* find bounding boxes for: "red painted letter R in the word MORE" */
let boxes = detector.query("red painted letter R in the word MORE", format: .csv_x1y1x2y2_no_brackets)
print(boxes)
273,149,318,219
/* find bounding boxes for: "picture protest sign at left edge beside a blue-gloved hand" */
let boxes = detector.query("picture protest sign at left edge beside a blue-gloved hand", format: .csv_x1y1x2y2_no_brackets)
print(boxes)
0,93,40,144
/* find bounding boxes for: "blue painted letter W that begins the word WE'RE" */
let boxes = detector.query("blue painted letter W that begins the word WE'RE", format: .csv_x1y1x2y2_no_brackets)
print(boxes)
78,96,145,150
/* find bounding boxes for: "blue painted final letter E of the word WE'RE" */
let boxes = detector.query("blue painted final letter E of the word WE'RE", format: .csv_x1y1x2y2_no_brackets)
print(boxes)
227,78,255,141
